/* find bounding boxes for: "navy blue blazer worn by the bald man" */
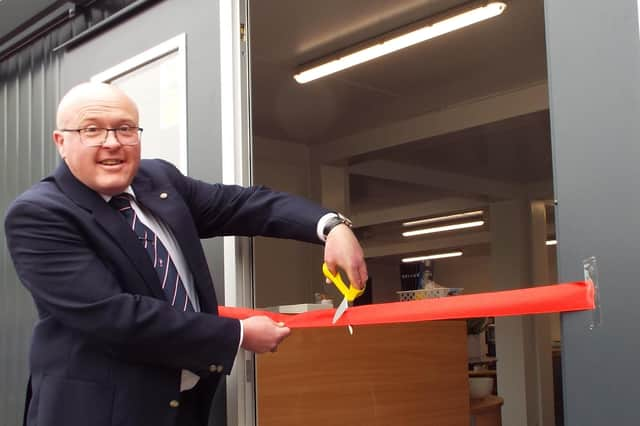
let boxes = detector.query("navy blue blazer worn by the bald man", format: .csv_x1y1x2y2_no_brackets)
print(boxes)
5,160,328,426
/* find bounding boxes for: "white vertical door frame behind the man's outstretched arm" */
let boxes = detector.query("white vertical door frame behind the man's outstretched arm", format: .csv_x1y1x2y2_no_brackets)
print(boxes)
219,0,257,425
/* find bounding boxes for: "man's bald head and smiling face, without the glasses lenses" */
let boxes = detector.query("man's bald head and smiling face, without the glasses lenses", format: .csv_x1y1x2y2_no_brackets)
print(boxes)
53,86,140,195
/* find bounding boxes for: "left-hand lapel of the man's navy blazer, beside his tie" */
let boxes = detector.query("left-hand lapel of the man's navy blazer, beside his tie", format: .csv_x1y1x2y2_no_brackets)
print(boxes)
54,162,165,299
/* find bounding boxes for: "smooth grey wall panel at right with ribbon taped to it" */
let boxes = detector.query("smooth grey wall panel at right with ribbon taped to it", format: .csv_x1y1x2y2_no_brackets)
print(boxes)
545,0,640,426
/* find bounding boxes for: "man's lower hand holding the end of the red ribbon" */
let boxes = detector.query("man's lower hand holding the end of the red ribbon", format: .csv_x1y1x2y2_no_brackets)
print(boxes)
241,316,291,354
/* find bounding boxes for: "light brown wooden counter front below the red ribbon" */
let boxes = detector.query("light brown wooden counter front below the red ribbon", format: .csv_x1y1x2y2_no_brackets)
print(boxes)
257,321,469,426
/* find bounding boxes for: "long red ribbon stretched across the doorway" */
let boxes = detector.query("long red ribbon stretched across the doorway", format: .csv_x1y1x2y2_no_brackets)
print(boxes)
219,281,595,328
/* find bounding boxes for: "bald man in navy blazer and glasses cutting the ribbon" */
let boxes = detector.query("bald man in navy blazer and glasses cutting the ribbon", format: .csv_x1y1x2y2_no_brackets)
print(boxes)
5,83,367,426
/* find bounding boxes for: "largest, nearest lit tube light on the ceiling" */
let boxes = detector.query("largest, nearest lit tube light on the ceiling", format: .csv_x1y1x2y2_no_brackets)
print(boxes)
293,0,507,83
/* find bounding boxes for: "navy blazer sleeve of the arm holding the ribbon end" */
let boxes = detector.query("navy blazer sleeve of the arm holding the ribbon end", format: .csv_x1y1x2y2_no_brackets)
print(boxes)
5,200,240,372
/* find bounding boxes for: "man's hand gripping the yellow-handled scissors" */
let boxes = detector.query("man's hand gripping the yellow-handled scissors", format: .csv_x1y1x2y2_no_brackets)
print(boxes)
324,224,369,289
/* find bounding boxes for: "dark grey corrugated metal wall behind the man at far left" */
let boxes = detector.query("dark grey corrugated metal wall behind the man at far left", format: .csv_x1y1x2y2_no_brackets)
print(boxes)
0,35,59,425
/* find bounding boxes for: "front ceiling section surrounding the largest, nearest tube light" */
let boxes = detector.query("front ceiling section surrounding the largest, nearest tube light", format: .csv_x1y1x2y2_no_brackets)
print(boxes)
250,0,546,144
